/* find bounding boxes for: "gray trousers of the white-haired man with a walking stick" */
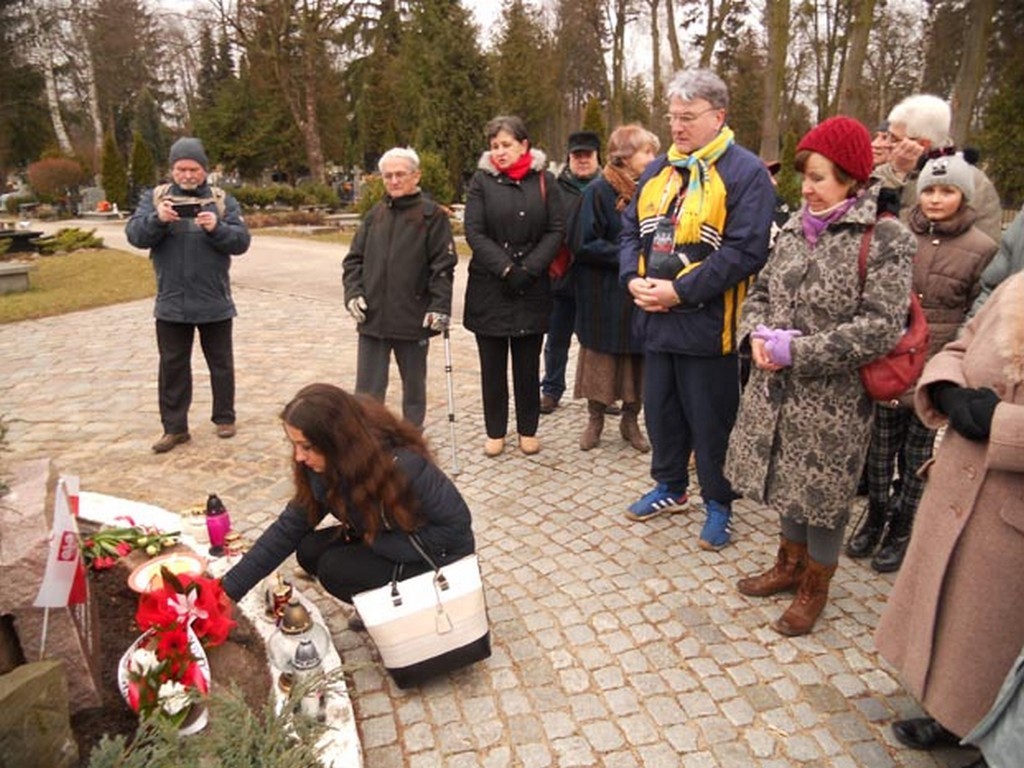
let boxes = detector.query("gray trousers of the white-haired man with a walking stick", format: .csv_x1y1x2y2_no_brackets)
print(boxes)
355,334,430,429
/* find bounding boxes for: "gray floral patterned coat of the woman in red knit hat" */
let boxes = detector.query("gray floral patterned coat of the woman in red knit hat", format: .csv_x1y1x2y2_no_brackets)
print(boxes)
725,187,916,528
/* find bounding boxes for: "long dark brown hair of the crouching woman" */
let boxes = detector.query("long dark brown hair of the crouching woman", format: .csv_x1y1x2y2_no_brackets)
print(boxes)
281,384,430,542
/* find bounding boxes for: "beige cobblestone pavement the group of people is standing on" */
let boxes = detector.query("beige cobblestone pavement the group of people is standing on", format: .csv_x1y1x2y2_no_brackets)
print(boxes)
0,219,973,768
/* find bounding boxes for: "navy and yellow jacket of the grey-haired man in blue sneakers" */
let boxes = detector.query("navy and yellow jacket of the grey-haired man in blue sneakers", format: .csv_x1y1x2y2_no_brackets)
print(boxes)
618,144,775,357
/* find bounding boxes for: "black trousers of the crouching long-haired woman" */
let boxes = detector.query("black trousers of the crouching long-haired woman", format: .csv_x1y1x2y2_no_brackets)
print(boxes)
295,525,430,603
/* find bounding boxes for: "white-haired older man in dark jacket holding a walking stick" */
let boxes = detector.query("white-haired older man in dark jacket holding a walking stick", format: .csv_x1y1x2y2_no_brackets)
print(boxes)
342,146,458,428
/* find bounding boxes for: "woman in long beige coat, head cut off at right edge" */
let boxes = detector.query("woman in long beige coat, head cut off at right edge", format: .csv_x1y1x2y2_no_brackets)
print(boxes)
876,272,1024,749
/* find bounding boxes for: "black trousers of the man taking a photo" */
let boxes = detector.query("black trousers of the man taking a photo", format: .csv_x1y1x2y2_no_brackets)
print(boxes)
157,317,234,434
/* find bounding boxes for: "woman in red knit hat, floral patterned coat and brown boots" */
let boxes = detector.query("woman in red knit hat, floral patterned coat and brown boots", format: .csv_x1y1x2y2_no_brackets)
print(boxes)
726,116,916,636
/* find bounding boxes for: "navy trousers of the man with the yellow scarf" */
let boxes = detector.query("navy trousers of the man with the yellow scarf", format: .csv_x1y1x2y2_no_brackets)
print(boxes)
643,352,739,506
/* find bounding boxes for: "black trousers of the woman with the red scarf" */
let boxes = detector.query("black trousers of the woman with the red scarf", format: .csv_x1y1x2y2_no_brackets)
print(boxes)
476,334,544,437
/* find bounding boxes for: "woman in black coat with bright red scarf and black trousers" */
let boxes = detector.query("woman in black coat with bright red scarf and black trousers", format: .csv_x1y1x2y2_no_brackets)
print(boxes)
463,116,564,456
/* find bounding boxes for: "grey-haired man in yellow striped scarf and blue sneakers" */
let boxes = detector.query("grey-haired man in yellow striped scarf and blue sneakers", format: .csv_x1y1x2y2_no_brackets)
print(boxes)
618,70,775,550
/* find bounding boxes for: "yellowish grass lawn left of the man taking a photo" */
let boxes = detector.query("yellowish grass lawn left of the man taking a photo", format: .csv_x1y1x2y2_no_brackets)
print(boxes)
0,248,157,323
